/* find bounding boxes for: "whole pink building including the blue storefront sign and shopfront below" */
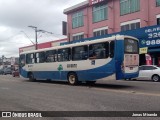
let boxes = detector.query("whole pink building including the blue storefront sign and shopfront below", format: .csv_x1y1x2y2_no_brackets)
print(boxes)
64,0,160,65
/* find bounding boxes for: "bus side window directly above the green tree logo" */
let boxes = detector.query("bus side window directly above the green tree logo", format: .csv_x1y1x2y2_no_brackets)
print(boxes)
57,48,71,62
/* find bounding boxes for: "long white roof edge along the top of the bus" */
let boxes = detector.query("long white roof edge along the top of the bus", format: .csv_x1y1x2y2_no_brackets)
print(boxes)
20,35,138,54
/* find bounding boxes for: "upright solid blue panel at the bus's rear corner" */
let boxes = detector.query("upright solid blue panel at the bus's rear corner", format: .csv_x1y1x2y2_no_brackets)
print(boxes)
115,40,124,80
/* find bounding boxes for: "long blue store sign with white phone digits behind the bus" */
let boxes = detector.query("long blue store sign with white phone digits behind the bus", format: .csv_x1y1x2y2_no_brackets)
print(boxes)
60,25,160,48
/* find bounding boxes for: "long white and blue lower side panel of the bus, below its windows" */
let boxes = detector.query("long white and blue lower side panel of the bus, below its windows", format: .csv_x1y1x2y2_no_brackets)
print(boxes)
22,58,115,81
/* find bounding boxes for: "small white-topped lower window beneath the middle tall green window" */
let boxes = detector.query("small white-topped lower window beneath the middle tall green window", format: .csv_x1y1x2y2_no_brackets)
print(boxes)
93,27,108,37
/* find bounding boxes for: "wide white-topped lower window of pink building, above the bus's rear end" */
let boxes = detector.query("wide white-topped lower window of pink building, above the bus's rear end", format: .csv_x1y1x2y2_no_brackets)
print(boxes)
121,20,140,31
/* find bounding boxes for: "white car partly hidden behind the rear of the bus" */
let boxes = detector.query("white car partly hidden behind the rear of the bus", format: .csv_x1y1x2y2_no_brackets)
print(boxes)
136,65,160,82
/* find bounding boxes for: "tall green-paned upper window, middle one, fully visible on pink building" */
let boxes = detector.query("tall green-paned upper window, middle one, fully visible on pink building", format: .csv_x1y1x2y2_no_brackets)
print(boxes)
92,4,108,22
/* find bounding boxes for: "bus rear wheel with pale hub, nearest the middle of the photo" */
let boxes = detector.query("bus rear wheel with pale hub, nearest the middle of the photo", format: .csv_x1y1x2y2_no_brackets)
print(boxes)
68,72,78,85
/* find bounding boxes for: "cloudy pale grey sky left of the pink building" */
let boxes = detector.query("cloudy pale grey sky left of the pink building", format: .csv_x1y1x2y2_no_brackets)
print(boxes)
0,0,85,57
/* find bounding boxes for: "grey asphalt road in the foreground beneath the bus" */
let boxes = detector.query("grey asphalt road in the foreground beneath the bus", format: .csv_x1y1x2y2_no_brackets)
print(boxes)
0,75,160,120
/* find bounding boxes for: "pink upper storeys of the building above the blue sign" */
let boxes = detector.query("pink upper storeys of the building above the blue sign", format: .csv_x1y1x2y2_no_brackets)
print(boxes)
64,0,160,41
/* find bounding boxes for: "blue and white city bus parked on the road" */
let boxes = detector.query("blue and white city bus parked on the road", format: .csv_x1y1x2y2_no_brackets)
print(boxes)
20,35,139,85
